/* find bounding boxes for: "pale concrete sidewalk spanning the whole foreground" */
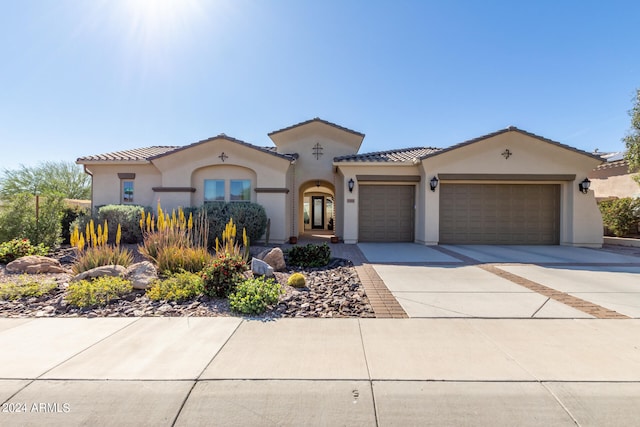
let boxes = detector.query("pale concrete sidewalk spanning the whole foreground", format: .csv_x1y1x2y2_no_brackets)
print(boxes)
0,317,640,426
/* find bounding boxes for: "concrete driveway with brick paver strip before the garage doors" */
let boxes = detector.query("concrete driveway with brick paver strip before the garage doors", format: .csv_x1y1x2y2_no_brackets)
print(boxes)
358,243,640,318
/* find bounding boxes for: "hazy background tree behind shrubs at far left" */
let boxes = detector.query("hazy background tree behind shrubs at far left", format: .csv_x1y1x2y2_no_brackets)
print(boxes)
0,162,91,200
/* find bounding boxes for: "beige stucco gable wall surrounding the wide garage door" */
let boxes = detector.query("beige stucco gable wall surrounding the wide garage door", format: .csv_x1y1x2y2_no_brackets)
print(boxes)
423,132,602,246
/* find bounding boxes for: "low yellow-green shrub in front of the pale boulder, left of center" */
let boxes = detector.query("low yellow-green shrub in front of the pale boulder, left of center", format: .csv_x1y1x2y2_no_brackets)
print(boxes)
65,276,133,308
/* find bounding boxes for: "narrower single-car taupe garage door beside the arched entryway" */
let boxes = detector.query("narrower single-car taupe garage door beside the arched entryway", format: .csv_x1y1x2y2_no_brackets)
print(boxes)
358,185,415,242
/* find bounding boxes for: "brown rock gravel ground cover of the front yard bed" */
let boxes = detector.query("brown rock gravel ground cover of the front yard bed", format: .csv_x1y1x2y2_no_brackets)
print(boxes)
0,247,375,319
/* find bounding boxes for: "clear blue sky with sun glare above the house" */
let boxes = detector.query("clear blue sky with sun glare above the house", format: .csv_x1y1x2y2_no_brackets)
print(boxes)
0,0,640,169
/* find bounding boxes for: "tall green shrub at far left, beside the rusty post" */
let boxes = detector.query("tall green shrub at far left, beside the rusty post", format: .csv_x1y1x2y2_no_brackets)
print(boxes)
0,193,65,248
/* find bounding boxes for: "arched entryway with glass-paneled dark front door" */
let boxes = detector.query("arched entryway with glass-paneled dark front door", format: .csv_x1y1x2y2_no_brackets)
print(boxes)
298,179,336,235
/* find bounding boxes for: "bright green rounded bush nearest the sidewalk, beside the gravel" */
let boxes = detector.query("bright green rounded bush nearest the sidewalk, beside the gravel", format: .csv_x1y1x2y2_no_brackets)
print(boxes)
229,277,283,314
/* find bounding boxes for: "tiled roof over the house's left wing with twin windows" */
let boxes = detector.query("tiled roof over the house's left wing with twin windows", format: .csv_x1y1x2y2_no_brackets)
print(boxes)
76,134,298,163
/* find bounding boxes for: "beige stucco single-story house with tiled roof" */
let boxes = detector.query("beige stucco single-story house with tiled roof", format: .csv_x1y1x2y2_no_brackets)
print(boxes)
77,118,602,247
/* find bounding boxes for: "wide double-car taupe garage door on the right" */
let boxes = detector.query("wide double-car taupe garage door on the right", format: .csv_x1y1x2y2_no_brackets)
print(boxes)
440,183,560,245
